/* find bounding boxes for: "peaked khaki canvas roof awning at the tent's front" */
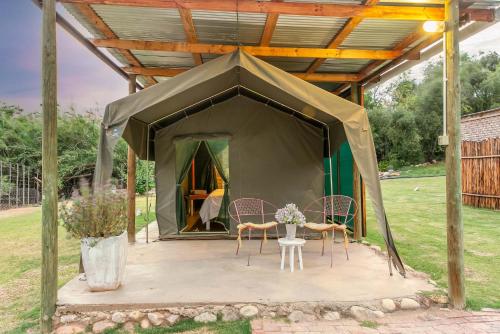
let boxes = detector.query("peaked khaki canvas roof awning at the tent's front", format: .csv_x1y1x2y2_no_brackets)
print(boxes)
103,50,364,159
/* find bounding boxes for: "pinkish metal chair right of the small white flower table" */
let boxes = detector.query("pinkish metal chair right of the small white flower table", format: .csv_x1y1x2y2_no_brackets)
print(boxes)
304,195,357,267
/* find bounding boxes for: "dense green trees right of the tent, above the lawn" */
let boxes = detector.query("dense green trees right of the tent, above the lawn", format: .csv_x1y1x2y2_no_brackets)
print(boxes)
365,52,500,165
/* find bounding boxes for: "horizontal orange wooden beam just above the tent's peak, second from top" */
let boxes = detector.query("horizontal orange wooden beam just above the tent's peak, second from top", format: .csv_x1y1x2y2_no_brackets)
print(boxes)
92,39,401,59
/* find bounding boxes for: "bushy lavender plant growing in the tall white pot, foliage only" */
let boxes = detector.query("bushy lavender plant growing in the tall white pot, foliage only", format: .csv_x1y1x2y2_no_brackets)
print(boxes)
60,183,128,239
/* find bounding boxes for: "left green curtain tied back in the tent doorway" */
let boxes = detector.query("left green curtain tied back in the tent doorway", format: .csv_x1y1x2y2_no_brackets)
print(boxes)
175,140,200,233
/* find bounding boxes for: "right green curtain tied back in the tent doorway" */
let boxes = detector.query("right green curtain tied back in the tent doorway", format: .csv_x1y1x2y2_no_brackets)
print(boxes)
205,139,230,230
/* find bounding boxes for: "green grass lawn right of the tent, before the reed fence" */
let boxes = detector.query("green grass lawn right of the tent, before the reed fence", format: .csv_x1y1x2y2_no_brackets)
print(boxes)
367,177,500,309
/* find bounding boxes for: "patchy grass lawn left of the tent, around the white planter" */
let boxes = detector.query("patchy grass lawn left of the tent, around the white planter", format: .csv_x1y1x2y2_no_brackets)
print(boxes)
0,197,155,333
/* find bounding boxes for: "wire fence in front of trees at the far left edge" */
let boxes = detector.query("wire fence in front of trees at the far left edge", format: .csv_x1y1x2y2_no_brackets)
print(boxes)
0,160,42,210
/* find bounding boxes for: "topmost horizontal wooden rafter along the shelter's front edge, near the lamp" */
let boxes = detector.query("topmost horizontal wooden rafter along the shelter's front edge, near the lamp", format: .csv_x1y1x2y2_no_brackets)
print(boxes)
60,0,495,21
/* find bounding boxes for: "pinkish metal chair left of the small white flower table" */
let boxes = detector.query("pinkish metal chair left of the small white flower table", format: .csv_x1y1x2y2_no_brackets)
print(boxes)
229,198,279,265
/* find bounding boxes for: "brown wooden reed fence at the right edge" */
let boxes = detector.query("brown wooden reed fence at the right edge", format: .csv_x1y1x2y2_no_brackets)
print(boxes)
462,138,500,210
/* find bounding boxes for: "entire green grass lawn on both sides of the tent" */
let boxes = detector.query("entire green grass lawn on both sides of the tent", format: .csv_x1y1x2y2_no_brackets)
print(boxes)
0,177,500,333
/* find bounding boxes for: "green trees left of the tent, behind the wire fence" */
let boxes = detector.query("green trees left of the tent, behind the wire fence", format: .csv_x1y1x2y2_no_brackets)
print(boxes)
0,103,127,195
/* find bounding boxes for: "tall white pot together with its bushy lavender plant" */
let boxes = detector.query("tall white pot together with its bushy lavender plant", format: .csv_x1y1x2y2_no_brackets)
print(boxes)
60,184,128,291
